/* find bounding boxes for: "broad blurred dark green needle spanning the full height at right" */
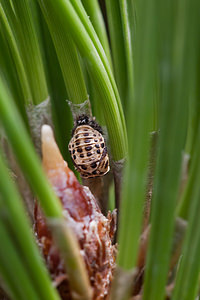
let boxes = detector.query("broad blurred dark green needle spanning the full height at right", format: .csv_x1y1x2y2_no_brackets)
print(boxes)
143,0,190,300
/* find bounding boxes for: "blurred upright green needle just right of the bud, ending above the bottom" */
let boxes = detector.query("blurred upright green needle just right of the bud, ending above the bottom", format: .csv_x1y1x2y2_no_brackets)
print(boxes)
117,1,156,272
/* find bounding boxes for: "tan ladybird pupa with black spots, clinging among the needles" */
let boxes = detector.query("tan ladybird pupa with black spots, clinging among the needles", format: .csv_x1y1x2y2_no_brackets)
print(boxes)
68,115,110,178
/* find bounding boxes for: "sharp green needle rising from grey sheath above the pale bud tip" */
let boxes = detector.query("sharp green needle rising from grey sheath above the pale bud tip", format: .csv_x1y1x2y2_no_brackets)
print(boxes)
12,0,48,104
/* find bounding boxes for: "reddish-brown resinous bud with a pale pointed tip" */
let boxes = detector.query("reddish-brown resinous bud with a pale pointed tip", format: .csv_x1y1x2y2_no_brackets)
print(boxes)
35,125,116,300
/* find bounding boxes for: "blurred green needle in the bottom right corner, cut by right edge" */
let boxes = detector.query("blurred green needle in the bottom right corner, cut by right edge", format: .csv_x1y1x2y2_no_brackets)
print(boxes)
172,130,200,300
